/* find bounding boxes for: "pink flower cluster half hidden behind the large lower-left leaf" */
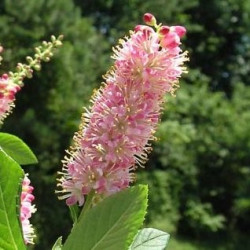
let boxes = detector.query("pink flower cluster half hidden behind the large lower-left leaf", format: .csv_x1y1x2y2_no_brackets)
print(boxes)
20,174,36,244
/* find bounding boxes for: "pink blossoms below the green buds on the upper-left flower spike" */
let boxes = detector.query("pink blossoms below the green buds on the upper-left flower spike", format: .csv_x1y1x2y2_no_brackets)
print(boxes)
0,74,20,123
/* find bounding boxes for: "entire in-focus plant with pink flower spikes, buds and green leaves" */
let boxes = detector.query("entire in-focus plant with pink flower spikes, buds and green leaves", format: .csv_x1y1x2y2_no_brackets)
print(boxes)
0,13,188,250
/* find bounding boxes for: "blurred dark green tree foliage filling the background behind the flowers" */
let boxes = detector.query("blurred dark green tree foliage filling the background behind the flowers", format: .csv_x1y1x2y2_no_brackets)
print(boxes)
0,0,250,249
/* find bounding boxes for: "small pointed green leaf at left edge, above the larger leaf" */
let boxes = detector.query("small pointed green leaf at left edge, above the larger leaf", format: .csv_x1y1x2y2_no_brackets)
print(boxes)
0,133,38,165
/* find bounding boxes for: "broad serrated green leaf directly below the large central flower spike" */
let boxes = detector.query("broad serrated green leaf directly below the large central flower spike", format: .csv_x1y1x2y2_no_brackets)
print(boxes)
63,185,148,250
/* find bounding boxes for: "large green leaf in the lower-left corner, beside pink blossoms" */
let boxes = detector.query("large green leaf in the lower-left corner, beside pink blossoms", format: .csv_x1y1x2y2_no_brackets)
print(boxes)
0,150,26,250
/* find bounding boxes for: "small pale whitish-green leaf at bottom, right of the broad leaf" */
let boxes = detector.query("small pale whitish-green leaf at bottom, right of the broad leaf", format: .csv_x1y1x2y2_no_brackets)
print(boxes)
129,228,170,250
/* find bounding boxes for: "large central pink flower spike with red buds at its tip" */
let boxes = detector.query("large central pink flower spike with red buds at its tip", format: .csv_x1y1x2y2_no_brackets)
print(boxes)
58,13,187,206
